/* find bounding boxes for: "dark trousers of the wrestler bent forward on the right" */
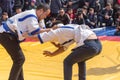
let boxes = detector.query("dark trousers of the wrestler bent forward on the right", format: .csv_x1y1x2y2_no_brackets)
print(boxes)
64,39,102,80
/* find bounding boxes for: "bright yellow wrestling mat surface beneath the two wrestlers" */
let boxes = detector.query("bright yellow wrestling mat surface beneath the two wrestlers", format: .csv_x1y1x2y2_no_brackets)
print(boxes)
0,41,120,80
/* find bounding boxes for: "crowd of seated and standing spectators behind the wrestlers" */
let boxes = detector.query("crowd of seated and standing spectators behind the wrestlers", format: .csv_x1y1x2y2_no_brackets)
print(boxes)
0,0,120,32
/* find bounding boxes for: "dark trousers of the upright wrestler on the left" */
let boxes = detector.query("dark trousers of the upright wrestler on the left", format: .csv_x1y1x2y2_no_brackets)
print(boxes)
0,32,25,80
